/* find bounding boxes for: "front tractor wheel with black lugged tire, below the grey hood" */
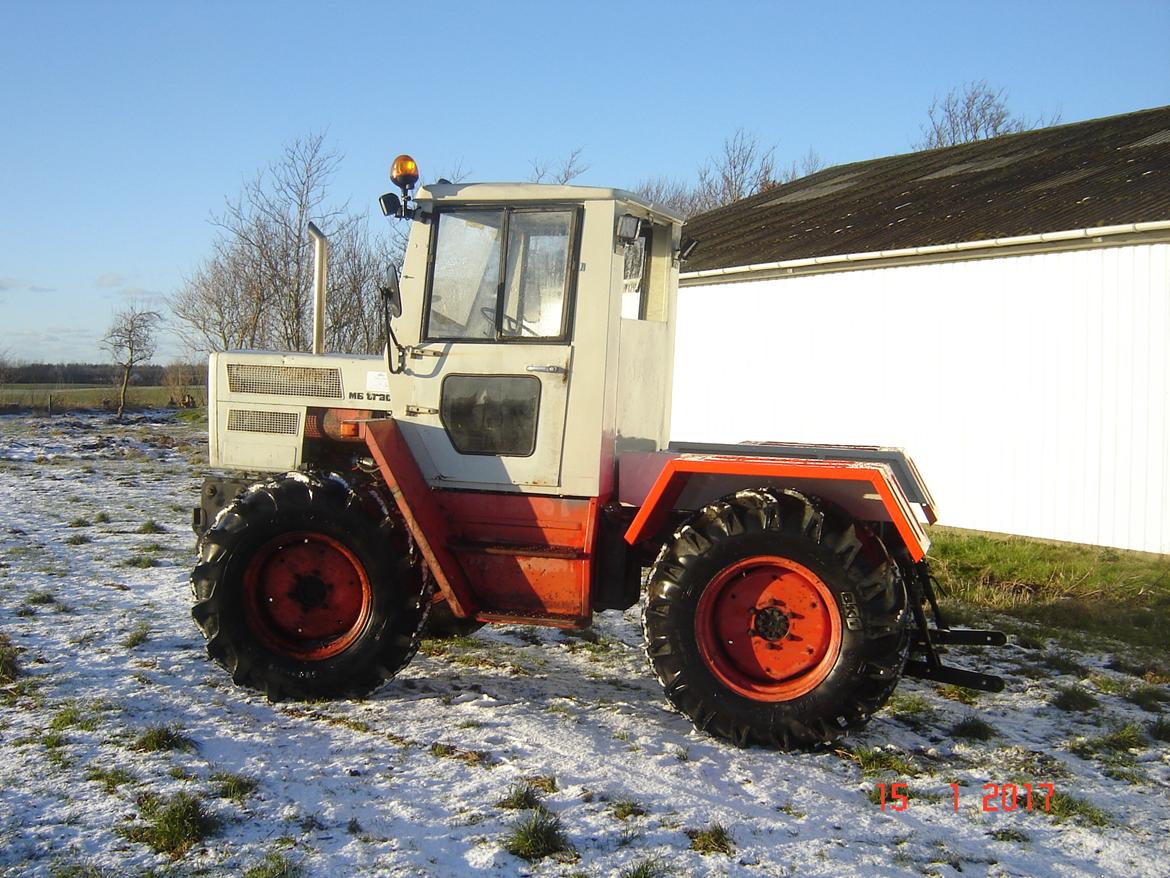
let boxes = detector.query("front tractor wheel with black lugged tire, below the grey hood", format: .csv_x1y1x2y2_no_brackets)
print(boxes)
191,472,431,700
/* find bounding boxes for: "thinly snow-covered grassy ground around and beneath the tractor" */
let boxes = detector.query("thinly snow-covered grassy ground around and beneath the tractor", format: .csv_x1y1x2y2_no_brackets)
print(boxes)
0,416,1170,878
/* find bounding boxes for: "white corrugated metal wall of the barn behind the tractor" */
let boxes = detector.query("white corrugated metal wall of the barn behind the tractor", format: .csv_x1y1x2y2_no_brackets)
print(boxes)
670,243,1170,553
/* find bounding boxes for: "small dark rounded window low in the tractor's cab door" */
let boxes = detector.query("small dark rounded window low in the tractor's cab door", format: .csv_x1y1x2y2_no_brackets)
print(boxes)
439,375,541,458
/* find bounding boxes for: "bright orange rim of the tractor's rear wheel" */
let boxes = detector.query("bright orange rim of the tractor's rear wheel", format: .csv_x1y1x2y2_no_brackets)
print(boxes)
695,555,841,701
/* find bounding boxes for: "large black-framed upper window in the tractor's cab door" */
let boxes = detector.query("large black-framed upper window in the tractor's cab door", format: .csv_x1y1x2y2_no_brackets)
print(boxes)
424,208,573,339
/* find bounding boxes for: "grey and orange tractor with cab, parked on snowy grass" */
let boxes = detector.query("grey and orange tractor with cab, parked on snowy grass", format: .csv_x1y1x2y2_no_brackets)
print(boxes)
191,156,1004,749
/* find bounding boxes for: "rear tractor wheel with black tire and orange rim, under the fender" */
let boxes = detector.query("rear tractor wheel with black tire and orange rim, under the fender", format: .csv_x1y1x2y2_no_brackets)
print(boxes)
642,489,910,750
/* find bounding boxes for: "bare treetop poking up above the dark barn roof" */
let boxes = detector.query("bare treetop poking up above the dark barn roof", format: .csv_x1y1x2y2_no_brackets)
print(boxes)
914,80,1060,150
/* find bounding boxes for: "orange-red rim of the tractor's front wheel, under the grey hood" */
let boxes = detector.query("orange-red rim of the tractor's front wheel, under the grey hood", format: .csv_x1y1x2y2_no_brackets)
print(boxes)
243,530,373,660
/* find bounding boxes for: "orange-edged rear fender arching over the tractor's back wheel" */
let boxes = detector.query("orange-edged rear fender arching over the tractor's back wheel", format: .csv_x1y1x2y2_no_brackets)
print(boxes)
619,452,930,561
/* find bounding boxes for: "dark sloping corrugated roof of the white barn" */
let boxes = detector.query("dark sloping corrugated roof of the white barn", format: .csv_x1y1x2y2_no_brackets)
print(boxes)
684,107,1170,272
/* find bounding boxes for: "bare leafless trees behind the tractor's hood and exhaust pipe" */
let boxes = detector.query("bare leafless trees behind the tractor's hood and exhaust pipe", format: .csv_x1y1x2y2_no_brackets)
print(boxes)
171,133,393,352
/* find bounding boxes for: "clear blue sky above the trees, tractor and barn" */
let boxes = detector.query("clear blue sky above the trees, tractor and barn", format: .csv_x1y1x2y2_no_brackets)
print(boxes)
0,0,1170,362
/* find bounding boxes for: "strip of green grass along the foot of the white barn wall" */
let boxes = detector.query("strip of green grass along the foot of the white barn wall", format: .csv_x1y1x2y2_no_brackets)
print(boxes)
930,528,1170,647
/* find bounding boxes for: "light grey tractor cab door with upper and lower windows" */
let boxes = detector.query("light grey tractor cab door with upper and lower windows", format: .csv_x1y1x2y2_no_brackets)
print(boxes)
402,205,580,489
